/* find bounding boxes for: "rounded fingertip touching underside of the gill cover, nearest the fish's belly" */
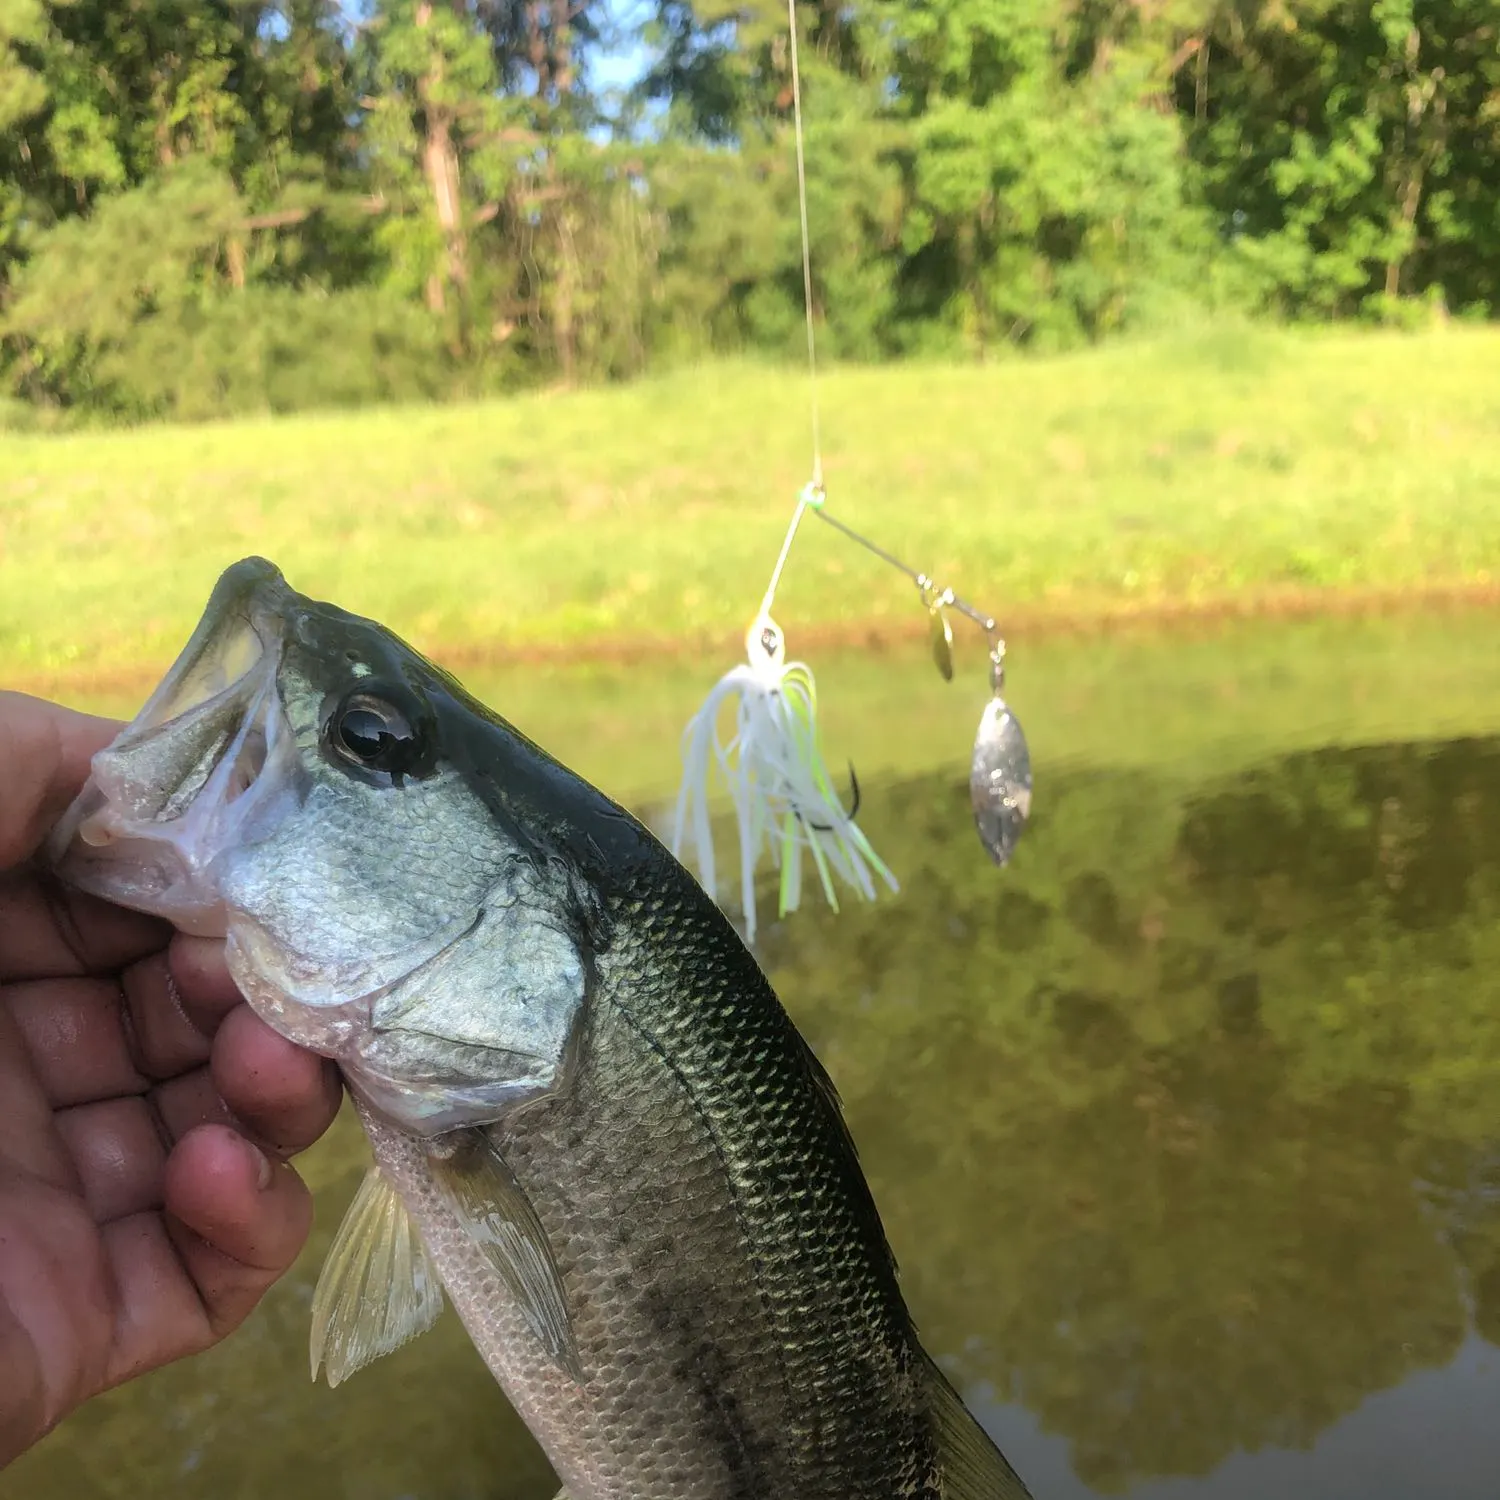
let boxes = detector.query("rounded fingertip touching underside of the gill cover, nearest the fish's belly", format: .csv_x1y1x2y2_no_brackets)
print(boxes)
210,1005,344,1157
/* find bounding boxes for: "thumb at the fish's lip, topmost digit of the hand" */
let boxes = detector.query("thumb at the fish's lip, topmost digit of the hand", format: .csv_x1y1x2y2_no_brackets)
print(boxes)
0,692,122,870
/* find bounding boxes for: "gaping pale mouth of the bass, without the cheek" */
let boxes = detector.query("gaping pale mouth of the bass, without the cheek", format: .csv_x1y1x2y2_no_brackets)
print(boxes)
48,558,300,936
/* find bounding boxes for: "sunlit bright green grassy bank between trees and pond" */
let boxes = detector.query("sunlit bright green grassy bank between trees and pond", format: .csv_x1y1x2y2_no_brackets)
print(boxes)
0,329,1500,681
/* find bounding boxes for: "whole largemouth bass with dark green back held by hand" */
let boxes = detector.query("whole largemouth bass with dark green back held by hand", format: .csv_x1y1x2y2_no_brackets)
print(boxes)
51,558,1026,1500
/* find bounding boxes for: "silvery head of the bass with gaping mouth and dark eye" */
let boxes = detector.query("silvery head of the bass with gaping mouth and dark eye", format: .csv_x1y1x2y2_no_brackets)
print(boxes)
50,558,624,1136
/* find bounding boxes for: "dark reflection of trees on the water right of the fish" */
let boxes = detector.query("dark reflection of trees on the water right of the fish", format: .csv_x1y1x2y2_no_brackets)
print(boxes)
770,741,1500,1497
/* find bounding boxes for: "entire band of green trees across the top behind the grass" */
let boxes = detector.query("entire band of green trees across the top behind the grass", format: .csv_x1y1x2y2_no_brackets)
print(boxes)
0,0,1500,416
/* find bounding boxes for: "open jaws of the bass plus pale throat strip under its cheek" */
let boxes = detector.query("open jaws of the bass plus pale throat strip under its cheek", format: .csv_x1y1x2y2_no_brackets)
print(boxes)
47,558,411,1058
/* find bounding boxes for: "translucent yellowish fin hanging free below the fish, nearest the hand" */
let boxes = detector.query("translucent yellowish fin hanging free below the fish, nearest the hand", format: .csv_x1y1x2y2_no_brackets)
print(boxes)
309,1167,443,1386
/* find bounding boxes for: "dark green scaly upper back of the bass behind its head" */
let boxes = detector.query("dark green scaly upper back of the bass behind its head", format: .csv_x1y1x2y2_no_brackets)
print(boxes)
588,870,939,1500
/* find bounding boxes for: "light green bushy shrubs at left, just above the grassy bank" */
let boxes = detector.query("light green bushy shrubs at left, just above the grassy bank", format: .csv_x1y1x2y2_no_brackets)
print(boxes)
0,159,443,420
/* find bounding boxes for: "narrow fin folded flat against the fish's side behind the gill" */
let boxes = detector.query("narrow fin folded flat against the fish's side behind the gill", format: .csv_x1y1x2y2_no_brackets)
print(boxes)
428,1131,584,1380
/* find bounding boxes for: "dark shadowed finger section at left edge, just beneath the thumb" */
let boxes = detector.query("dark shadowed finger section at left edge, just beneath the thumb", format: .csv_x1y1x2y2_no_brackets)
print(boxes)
0,876,171,981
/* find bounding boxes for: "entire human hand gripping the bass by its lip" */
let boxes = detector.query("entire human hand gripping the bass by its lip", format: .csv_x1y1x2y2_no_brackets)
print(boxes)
0,693,341,1467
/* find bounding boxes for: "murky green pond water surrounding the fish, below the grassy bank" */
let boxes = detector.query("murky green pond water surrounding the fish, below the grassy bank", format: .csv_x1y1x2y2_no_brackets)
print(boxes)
0,617,1500,1500
